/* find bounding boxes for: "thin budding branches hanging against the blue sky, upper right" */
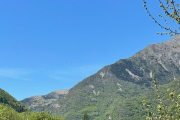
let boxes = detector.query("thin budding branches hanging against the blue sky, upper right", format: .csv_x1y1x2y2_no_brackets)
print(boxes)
143,0,180,36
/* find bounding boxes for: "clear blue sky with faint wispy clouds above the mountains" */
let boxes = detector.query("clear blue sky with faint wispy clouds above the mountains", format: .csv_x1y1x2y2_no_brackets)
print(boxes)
0,0,175,100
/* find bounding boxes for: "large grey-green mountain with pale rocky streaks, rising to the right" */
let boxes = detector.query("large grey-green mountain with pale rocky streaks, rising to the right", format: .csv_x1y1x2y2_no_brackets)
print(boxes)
21,35,180,120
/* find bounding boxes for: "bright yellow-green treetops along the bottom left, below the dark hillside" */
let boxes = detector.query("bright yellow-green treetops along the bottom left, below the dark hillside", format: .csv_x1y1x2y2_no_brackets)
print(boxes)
0,104,64,120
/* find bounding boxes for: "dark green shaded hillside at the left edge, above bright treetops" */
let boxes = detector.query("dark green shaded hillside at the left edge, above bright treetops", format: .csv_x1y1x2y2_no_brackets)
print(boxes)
0,88,29,112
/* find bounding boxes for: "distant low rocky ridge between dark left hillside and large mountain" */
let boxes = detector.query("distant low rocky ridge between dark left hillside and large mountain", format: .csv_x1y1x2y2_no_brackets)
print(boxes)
21,89,69,112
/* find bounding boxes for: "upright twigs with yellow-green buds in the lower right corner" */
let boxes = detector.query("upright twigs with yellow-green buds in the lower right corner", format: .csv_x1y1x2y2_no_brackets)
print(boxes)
142,78,180,120
